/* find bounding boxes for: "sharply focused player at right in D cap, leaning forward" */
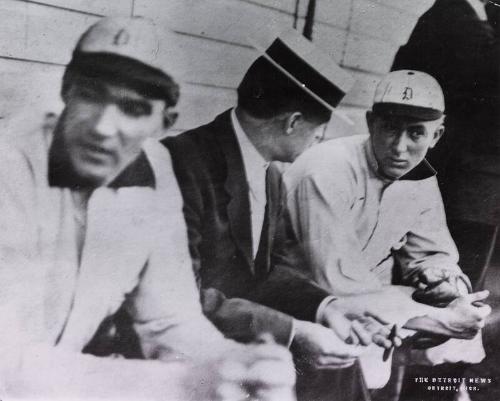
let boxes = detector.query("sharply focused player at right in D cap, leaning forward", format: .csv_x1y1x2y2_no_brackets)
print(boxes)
274,71,490,387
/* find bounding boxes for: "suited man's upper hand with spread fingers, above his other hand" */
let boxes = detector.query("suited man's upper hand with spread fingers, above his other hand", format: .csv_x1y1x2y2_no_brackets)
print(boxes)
320,300,401,348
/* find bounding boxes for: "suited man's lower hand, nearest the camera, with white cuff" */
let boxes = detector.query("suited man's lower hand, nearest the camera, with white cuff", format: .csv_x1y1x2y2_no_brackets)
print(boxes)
292,320,365,369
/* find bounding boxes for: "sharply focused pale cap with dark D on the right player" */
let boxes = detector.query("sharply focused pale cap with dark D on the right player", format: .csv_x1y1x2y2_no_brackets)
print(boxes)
372,70,444,121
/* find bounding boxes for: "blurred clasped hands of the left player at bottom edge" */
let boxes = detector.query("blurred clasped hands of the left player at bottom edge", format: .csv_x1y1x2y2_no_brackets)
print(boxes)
187,339,295,401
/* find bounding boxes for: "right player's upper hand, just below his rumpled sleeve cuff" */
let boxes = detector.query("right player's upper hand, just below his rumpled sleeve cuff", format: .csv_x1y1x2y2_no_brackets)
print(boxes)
413,267,468,306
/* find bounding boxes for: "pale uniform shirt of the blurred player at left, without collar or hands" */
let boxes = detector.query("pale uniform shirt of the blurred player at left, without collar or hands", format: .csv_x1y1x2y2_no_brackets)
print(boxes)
0,132,227,394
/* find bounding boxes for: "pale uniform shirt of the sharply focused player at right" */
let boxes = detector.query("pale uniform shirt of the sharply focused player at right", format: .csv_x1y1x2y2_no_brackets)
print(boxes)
275,135,467,295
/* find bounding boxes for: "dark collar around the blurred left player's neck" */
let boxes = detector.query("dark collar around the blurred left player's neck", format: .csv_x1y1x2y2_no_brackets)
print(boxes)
48,130,156,190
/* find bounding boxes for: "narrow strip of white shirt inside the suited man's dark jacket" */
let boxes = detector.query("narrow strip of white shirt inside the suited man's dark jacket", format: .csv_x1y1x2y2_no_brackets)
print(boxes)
231,109,269,258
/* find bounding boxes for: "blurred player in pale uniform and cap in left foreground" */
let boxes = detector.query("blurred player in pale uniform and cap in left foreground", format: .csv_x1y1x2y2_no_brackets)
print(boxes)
0,18,294,400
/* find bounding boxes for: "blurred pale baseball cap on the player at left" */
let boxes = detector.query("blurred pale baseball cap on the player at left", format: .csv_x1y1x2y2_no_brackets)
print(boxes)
63,17,179,105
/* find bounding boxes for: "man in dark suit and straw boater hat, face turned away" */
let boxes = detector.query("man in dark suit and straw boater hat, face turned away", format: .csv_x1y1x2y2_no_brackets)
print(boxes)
163,31,387,394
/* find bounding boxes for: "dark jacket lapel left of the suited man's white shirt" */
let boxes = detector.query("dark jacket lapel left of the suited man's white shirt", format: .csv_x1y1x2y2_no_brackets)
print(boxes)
216,111,253,271
